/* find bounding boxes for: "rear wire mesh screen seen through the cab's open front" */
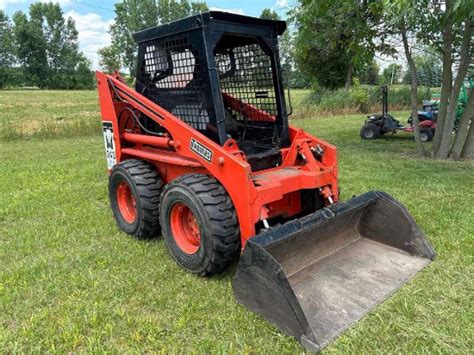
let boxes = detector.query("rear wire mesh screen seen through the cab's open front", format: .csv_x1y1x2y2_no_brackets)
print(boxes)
215,44,278,121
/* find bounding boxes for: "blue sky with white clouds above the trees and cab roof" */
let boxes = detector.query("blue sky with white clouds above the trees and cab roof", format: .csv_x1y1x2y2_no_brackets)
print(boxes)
0,0,289,69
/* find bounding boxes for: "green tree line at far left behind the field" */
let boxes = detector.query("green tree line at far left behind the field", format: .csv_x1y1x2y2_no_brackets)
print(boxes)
0,2,94,89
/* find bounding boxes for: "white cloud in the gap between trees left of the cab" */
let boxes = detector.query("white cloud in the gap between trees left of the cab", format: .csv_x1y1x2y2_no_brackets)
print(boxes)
63,10,114,69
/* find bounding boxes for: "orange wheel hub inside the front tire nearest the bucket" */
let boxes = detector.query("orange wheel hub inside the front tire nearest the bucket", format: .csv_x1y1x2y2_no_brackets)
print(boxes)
170,202,201,254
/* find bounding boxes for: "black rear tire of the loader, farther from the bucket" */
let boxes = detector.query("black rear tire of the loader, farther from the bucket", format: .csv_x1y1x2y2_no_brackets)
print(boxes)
109,159,163,239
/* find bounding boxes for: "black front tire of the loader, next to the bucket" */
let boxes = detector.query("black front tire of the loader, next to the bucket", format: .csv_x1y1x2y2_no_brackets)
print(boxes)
160,174,240,276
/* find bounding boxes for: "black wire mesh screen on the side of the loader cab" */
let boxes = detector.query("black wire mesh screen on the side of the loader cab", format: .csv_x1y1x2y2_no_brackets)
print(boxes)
141,37,209,130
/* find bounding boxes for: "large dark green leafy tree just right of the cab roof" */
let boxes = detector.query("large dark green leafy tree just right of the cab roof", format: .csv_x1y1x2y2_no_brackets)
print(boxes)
291,0,391,89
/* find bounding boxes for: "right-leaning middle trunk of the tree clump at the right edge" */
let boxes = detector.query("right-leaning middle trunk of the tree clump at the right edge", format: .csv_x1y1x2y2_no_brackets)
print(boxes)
437,20,472,159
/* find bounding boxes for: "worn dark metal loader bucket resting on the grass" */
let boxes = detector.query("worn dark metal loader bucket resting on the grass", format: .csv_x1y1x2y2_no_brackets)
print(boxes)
233,192,435,352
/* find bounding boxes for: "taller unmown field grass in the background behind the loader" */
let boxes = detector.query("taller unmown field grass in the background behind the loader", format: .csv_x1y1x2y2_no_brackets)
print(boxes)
0,88,422,141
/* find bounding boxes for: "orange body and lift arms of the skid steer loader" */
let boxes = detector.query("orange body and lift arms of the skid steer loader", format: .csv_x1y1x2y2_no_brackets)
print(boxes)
97,72,339,248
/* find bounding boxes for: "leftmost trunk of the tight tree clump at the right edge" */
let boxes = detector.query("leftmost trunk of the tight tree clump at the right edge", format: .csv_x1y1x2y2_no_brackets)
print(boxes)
432,0,454,156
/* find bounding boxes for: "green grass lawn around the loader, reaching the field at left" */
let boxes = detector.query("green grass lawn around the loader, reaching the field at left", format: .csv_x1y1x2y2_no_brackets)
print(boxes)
0,91,474,354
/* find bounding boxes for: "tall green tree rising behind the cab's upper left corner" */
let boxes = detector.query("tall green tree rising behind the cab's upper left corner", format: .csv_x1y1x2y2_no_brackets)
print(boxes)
111,0,208,77
